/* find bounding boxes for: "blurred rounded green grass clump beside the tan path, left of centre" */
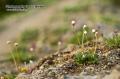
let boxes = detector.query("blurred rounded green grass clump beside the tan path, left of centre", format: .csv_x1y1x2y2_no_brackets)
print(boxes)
20,29,39,43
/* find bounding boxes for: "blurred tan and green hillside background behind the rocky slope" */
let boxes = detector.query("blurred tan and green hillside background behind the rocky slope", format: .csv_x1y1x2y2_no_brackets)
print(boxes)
0,0,120,78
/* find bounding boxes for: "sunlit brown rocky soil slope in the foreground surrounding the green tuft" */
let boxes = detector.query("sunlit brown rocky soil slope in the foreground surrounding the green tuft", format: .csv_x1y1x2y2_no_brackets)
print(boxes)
16,45,120,79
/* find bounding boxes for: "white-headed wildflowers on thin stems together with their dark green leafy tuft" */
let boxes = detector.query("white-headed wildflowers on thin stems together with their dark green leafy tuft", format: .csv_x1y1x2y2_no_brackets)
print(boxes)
72,21,101,64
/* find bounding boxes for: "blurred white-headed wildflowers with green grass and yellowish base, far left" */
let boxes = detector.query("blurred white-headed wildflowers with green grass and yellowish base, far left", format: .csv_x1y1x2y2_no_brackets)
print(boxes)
6,41,35,72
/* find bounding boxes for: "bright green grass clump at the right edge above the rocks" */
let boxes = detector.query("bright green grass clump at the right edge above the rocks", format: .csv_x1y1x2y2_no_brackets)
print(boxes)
105,36,120,48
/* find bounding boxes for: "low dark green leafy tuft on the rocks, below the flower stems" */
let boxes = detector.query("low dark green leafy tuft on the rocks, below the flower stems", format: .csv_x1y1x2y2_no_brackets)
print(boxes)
74,51,98,64
